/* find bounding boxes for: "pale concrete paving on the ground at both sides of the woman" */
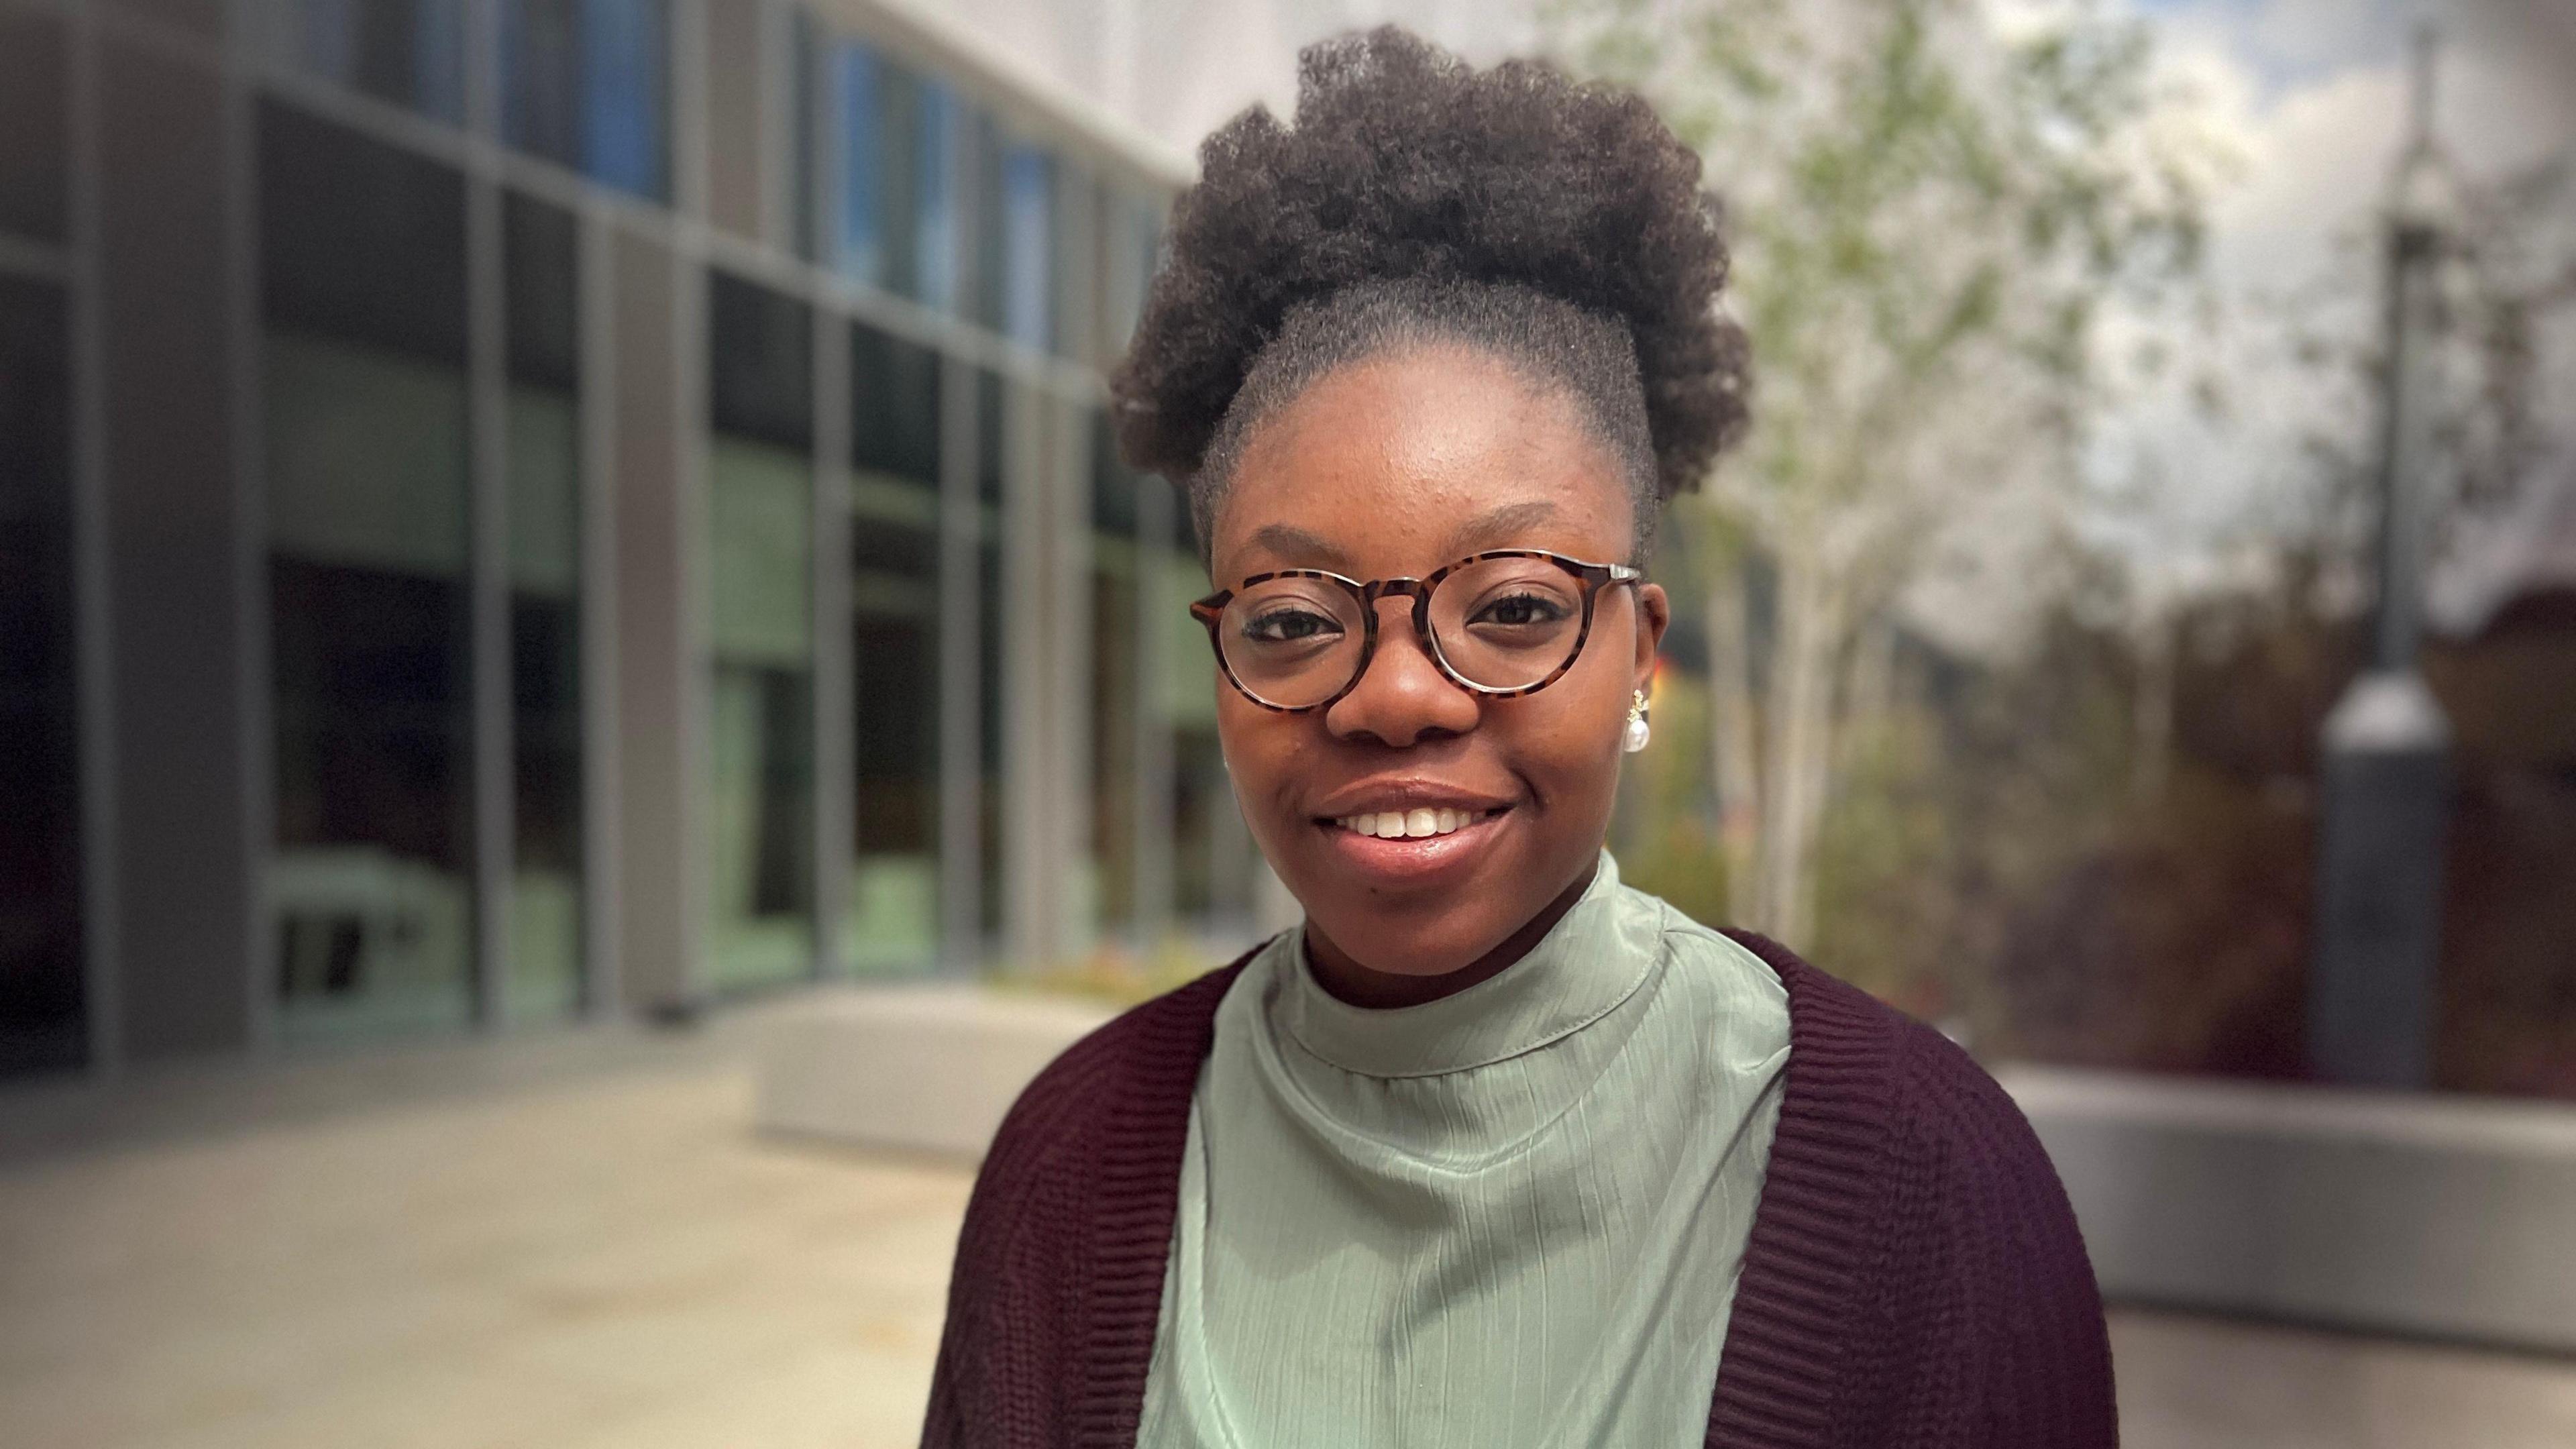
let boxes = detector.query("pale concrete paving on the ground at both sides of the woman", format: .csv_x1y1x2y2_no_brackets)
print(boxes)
0,1024,2576,1449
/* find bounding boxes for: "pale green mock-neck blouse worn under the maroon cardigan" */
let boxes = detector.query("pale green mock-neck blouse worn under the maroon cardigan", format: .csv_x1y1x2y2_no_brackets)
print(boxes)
1138,851,1788,1449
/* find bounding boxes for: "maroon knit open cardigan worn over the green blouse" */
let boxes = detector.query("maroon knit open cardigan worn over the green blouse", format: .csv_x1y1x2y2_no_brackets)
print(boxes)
922,933,2120,1449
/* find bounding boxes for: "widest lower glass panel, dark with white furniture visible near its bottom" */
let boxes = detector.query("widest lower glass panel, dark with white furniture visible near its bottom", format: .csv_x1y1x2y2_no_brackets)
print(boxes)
260,103,474,1036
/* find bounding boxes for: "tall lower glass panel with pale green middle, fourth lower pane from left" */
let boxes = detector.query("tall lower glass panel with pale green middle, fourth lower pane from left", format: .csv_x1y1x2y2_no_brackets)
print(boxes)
706,273,814,990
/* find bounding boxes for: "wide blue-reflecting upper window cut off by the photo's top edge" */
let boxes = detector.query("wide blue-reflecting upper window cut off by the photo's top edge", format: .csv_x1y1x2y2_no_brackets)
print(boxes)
497,0,669,199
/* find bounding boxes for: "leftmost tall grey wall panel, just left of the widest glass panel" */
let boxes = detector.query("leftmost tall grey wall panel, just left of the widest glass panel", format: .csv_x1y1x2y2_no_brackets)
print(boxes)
98,39,251,1060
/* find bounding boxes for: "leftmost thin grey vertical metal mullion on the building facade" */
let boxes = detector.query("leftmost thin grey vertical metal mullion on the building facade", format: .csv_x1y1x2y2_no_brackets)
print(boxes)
64,5,123,1080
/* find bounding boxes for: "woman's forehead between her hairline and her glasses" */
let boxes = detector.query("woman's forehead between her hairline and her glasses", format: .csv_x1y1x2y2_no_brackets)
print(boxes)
1211,343,1635,583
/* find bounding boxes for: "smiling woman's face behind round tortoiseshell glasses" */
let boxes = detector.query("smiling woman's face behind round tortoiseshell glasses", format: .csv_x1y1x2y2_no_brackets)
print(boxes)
1211,345,1666,977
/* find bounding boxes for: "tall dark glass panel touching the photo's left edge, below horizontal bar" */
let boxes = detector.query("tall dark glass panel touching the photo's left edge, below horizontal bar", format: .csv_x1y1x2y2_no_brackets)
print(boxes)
0,276,88,1078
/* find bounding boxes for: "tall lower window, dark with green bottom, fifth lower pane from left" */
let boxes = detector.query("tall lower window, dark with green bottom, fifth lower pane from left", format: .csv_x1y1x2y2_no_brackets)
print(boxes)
840,322,941,975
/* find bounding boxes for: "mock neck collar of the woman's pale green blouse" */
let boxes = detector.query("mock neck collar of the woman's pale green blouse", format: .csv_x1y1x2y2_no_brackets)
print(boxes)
1275,851,1654,1078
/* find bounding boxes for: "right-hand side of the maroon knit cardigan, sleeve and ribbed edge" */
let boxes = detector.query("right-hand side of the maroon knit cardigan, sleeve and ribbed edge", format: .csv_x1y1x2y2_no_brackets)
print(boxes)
1708,936,2117,1449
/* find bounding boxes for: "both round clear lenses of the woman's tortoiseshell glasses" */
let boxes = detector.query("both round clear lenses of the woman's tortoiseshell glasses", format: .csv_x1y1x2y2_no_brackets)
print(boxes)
1216,559,1585,709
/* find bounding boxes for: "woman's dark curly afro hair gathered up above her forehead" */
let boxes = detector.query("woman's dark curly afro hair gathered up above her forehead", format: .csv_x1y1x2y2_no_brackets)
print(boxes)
1110,25,1747,559
